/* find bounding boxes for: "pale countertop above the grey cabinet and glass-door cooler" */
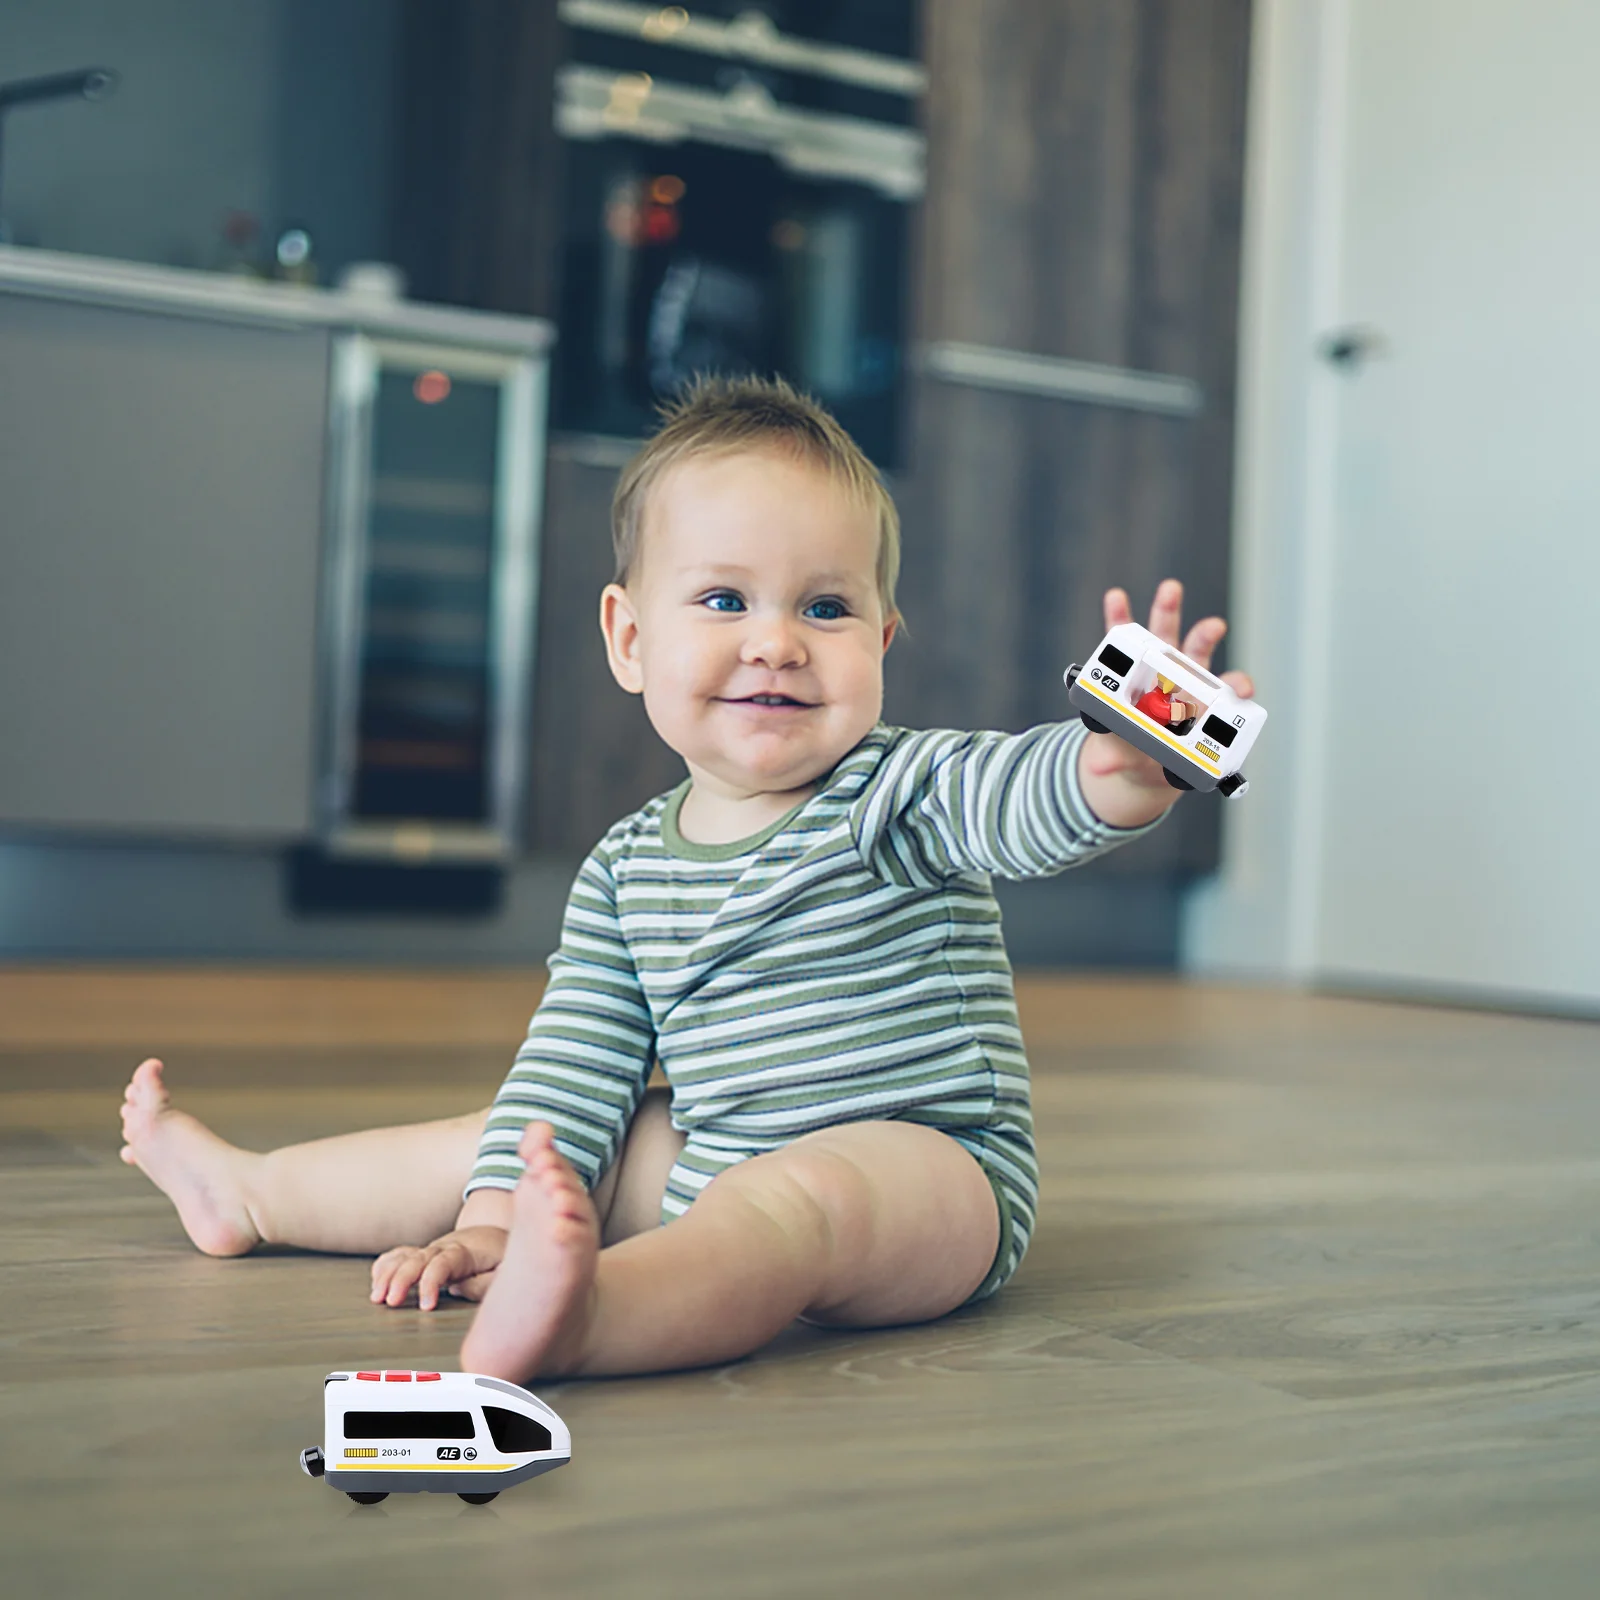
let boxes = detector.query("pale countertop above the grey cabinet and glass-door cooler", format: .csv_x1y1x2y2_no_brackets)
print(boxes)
0,245,555,355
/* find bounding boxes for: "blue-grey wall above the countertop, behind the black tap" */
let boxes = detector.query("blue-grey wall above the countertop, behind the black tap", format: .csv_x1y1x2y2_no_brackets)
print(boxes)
0,0,400,274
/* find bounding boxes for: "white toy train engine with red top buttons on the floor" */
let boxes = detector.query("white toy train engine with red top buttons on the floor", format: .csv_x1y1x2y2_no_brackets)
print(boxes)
301,1371,573,1506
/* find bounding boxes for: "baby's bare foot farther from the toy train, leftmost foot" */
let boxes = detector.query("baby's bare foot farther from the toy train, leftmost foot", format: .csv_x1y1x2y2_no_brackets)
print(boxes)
122,1061,261,1256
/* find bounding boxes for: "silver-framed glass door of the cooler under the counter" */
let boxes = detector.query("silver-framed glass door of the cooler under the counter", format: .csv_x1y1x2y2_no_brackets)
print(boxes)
322,334,544,861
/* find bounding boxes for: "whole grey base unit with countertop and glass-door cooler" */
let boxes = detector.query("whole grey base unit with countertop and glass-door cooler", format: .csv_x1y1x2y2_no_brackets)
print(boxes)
0,250,550,861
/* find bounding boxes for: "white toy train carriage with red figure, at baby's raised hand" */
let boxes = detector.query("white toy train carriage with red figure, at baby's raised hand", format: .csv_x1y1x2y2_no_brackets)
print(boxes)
1066,622,1267,800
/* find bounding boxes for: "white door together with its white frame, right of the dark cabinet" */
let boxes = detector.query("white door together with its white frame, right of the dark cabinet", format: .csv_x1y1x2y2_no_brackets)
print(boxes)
1186,0,1600,1006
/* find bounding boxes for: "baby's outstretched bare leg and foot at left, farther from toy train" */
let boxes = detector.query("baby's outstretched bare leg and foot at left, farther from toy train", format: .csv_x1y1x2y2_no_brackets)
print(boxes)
122,1061,486,1256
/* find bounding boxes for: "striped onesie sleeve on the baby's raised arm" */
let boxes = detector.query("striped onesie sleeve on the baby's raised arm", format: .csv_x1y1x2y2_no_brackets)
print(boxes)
853,722,1157,885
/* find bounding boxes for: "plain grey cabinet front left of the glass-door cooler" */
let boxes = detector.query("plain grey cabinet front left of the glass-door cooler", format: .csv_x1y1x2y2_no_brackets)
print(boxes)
0,293,328,840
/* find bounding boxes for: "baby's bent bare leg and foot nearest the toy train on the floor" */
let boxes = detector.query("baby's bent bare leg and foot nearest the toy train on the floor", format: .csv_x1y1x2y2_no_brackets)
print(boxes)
461,1122,1000,1381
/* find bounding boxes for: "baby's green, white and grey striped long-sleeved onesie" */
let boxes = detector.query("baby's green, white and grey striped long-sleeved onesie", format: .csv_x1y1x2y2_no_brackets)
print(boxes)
467,722,1154,1299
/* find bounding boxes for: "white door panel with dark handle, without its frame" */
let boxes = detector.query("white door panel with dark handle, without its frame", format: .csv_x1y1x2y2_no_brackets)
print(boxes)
1312,0,1600,1002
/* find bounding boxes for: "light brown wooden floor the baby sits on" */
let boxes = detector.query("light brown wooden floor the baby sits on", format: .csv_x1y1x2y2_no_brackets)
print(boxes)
0,971,1600,1600
